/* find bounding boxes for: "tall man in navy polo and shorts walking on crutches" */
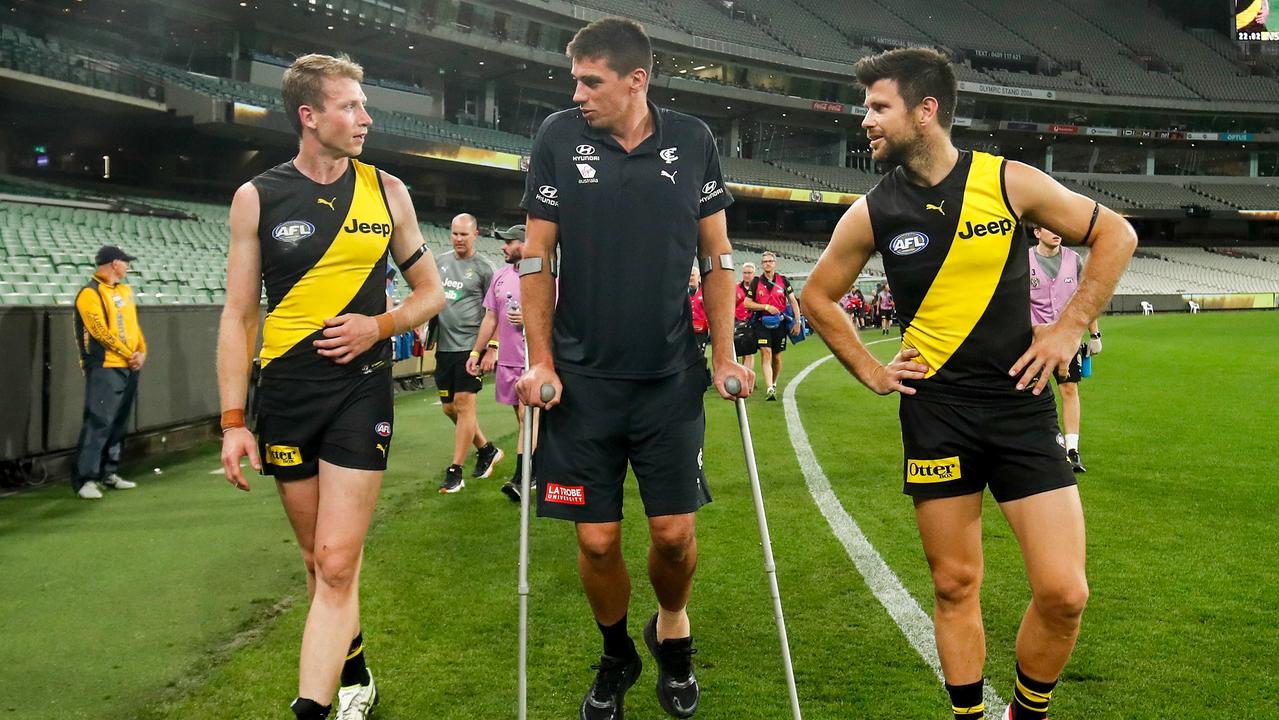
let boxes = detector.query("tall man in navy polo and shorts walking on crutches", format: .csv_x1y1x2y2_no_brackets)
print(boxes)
517,18,755,720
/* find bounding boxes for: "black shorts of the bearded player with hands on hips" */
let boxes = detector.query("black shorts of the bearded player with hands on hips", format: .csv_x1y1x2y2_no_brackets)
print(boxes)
899,394,1076,503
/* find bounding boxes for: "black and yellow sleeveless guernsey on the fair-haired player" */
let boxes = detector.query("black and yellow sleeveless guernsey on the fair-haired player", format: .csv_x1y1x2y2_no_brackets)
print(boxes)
252,160,393,380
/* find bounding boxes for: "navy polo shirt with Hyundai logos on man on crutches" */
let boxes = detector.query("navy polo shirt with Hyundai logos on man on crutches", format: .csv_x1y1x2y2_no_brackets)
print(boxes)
519,102,733,380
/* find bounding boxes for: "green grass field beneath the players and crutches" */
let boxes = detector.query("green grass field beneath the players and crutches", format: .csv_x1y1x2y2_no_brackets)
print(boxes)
0,312,1279,720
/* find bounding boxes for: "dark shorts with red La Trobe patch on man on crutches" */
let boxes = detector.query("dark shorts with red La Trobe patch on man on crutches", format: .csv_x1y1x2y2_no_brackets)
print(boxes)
535,364,711,523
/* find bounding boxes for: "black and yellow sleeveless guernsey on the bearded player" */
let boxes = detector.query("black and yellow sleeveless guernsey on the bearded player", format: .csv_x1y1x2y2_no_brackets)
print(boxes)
866,151,1051,404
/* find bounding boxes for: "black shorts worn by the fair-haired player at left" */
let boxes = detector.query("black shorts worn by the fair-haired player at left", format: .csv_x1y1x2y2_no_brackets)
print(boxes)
257,363,394,482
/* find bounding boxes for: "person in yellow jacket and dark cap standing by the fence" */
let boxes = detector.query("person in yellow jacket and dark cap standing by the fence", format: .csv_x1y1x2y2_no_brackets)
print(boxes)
72,246,147,500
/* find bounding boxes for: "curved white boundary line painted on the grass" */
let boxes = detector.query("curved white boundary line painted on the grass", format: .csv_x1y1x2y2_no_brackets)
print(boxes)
781,338,1008,717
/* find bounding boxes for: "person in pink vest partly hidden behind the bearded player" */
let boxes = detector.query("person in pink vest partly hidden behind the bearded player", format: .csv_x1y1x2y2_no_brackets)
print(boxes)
1027,224,1101,472
